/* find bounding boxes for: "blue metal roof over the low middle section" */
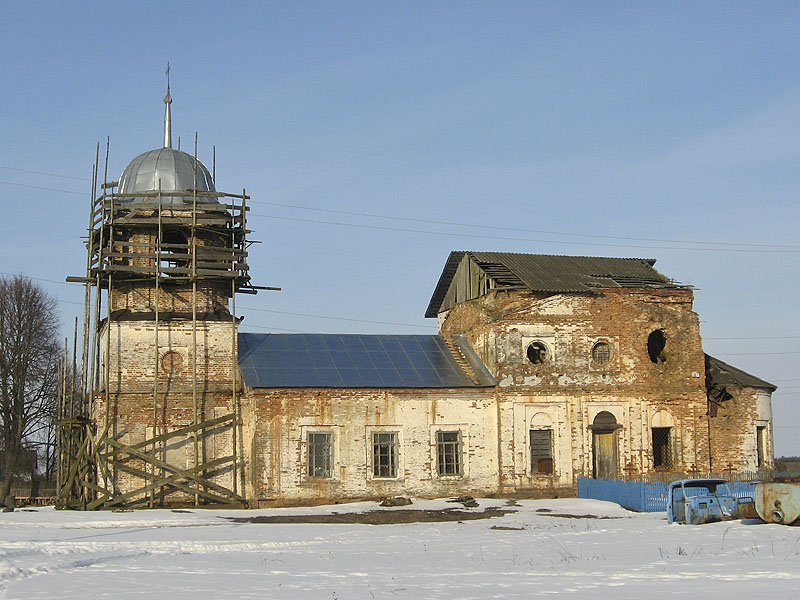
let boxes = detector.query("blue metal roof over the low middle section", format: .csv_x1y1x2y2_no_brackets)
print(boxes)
239,333,495,388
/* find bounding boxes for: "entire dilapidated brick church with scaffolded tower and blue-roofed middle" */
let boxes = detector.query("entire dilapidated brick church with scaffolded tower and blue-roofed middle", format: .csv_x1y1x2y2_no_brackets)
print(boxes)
60,92,775,508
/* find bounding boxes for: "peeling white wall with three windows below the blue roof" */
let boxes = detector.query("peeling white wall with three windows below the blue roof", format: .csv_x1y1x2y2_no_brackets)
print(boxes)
254,390,498,502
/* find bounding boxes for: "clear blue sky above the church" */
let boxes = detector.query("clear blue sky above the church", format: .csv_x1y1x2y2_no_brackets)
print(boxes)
0,2,800,455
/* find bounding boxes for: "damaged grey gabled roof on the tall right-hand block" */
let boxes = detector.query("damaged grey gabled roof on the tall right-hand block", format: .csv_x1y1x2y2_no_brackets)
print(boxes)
425,251,691,317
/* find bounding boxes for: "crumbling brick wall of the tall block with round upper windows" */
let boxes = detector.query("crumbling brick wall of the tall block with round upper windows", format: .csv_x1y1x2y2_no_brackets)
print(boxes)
441,289,709,491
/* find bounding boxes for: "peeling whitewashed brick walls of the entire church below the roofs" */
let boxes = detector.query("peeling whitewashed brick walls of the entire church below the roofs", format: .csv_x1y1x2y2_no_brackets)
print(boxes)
97,276,772,505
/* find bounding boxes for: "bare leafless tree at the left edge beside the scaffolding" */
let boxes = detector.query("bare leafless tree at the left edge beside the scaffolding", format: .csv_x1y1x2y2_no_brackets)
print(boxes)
0,275,59,507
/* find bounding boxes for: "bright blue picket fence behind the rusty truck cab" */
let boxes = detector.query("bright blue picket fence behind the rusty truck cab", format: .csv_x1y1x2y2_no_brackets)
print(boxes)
578,477,753,512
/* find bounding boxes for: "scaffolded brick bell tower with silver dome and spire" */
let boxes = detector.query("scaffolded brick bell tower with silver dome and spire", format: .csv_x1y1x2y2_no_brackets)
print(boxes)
59,68,263,509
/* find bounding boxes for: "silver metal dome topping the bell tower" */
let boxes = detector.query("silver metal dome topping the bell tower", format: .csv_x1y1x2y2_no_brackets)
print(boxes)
118,148,216,204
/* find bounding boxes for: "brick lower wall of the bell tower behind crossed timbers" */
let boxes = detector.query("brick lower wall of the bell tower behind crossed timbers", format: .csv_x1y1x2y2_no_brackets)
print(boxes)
93,312,242,502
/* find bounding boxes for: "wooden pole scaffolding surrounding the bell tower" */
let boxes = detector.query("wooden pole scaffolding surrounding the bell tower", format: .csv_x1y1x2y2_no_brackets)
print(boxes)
57,152,266,510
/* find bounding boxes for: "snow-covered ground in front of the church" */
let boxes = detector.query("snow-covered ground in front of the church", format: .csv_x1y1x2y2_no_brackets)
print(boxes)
0,499,800,600
